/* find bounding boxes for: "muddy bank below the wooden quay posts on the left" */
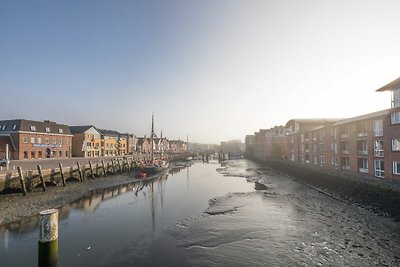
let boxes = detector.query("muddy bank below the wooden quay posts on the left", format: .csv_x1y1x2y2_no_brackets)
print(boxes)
0,173,144,224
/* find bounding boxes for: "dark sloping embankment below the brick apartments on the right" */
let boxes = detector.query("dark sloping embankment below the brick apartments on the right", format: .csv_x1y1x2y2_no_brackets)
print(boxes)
261,161,400,221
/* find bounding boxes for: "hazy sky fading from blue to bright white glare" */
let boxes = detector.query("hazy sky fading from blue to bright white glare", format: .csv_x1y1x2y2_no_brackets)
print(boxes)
0,0,400,143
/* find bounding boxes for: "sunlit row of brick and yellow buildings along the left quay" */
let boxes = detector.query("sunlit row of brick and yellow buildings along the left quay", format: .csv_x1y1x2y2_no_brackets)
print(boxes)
0,119,187,160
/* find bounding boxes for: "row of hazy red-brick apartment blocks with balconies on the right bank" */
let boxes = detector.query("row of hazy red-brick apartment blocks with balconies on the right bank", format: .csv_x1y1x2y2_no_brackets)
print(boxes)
246,78,400,180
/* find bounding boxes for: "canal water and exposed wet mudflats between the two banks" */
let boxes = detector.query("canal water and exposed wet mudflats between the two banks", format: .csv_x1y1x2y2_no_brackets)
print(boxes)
0,160,400,266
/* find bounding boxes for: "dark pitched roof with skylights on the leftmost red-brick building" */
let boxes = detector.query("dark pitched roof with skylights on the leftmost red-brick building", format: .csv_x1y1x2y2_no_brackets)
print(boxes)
0,119,71,135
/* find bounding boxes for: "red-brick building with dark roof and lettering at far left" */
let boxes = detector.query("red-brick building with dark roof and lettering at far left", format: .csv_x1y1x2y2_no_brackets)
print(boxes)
0,119,72,160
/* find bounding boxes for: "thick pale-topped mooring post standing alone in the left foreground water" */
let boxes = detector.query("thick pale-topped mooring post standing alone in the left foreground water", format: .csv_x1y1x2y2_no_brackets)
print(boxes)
38,209,58,267
